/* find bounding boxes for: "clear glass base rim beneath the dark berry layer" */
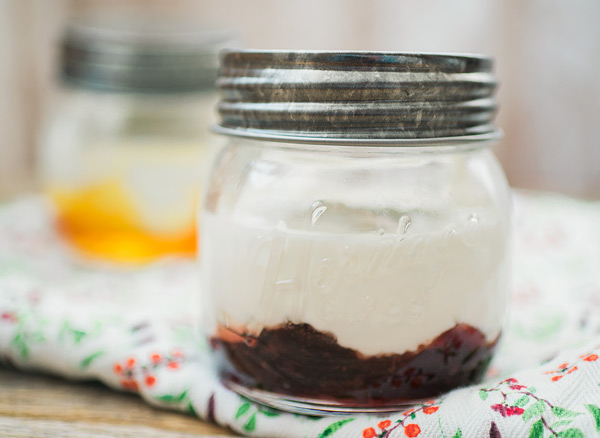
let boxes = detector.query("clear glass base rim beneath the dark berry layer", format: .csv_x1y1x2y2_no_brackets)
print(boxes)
223,379,430,416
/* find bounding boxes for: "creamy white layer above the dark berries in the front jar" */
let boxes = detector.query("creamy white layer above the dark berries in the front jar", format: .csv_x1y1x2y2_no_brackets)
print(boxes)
202,211,508,355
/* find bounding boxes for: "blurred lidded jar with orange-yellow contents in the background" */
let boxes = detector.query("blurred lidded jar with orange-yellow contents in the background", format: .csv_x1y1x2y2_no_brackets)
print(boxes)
39,17,228,263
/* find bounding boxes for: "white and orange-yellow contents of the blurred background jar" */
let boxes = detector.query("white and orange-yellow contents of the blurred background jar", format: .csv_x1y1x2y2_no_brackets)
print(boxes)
45,141,206,263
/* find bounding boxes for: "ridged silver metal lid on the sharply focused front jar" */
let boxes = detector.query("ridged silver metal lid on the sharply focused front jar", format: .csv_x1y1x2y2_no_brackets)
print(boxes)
215,50,500,144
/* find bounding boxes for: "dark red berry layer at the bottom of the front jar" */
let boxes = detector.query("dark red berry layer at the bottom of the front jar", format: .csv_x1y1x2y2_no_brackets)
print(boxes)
212,323,497,406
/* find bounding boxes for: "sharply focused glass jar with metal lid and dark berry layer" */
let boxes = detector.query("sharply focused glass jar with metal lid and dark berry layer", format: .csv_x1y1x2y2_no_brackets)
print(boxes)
201,51,510,413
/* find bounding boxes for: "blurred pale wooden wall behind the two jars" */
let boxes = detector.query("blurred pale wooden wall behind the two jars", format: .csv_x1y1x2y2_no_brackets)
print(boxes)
0,0,600,198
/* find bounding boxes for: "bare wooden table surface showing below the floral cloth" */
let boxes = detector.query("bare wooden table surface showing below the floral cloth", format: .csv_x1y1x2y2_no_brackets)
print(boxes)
0,368,238,438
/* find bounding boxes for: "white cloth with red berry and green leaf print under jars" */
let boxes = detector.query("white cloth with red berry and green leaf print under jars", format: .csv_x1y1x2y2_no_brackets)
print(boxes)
0,194,600,438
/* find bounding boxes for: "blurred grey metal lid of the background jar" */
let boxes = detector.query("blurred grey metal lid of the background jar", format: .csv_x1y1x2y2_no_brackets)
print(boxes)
61,15,230,93
